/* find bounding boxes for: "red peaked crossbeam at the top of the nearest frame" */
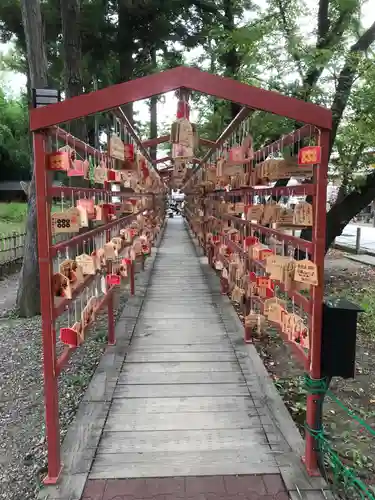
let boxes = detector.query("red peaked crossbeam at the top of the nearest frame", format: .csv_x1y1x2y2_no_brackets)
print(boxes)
30,66,332,132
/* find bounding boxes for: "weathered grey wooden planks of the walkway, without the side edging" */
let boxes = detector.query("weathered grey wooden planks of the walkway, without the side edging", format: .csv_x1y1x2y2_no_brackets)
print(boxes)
90,219,289,479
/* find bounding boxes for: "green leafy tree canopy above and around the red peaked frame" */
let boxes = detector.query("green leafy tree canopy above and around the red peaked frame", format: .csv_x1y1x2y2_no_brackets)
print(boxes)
0,0,375,235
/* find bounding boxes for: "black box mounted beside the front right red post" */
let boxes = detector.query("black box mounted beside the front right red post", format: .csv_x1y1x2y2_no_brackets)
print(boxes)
321,297,363,378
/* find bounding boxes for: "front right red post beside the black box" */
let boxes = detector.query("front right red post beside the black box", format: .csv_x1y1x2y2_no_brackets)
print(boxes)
304,130,330,475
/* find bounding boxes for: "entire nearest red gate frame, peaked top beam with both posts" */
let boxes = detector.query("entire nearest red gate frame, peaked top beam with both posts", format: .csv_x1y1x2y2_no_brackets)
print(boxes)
30,67,332,478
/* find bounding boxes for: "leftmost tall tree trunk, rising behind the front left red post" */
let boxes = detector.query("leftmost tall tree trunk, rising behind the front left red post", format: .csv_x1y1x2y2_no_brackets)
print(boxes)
17,0,48,317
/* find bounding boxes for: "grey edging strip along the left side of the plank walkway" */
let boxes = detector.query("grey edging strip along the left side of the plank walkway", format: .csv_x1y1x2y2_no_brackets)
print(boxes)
38,223,166,500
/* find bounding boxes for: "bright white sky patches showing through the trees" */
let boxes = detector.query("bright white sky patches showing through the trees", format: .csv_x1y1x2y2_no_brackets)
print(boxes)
0,0,375,162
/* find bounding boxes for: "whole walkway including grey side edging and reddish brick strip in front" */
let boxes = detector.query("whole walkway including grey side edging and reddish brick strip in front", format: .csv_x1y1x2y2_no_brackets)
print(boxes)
44,218,323,500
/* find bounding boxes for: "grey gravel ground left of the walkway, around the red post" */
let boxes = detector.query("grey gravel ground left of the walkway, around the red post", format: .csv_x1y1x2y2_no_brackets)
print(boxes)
0,276,131,500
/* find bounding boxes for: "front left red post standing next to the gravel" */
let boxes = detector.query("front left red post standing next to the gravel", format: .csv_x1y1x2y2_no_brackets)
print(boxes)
33,132,62,484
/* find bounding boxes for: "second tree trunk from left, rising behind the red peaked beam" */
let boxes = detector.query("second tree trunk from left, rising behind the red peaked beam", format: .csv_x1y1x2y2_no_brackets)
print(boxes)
60,0,87,142
